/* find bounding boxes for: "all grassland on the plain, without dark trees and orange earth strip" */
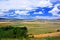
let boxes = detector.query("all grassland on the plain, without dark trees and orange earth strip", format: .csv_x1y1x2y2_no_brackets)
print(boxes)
0,22,60,40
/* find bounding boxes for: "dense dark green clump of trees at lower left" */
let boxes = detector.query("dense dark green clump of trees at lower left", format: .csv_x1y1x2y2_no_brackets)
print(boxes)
0,26,27,38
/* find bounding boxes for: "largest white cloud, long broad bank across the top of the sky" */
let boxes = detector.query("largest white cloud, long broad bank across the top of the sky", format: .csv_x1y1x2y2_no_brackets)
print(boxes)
0,0,52,10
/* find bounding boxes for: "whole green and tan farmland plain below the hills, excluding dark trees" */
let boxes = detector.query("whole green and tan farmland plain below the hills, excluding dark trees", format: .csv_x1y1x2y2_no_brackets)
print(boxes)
0,21,60,40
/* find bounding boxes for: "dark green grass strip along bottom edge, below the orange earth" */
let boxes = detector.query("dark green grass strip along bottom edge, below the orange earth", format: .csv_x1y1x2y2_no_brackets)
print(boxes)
1,36,60,40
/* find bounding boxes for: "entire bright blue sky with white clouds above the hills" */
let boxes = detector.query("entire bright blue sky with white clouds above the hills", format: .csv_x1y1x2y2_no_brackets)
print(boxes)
0,0,60,19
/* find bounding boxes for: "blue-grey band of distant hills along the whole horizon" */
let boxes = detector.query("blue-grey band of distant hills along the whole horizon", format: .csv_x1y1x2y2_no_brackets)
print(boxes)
0,18,60,22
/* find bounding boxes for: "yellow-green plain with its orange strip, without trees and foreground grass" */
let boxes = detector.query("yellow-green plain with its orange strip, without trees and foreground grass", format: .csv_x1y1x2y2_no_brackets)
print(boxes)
0,21,60,38
